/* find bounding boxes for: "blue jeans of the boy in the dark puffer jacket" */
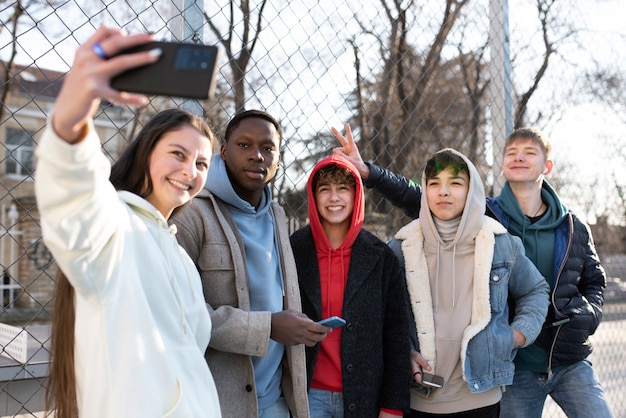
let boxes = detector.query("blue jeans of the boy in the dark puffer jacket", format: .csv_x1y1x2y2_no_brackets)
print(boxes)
500,360,613,418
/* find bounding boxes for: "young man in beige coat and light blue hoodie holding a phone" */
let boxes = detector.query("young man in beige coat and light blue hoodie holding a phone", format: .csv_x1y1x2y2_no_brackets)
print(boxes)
172,110,330,418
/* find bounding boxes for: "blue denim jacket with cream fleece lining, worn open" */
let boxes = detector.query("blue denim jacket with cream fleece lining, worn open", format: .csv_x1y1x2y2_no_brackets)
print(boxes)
389,216,549,392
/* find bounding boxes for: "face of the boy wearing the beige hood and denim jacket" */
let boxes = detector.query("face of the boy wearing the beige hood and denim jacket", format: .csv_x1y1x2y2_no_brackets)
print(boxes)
426,166,469,221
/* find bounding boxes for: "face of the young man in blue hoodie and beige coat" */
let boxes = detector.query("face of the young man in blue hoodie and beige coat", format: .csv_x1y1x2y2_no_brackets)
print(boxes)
221,117,280,208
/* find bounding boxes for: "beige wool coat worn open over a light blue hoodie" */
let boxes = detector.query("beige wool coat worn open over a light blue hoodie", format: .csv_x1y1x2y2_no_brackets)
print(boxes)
172,189,309,418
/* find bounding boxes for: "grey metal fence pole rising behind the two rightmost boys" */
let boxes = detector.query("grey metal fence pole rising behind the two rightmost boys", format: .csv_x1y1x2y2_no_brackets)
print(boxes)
489,0,513,195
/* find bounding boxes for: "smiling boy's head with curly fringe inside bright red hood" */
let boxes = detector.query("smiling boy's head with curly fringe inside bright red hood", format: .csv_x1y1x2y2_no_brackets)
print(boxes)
307,155,365,249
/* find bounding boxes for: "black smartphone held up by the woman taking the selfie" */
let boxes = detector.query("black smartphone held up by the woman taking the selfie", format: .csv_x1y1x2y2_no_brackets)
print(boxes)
111,42,219,100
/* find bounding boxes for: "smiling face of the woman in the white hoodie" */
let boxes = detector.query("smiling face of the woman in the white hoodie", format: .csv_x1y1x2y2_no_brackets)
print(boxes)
146,125,211,219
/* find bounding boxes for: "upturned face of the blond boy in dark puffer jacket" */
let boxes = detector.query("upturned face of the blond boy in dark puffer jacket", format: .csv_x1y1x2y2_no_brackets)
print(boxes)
502,138,553,183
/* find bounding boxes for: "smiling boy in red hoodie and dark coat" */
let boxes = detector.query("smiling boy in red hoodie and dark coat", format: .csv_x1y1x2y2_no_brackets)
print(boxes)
291,156,410,418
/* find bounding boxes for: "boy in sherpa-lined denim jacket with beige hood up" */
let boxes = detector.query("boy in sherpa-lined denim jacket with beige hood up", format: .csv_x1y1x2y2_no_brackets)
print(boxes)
389,148,549,418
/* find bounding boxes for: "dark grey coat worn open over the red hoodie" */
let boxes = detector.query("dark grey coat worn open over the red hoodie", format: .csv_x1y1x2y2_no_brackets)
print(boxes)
291,226,411,418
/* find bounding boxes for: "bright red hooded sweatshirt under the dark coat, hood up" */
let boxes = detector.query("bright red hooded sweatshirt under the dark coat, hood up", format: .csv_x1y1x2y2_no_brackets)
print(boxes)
307,155,365,392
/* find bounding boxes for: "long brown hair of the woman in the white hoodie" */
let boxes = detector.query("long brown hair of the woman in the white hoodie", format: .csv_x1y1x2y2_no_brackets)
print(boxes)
46,109,215,418
